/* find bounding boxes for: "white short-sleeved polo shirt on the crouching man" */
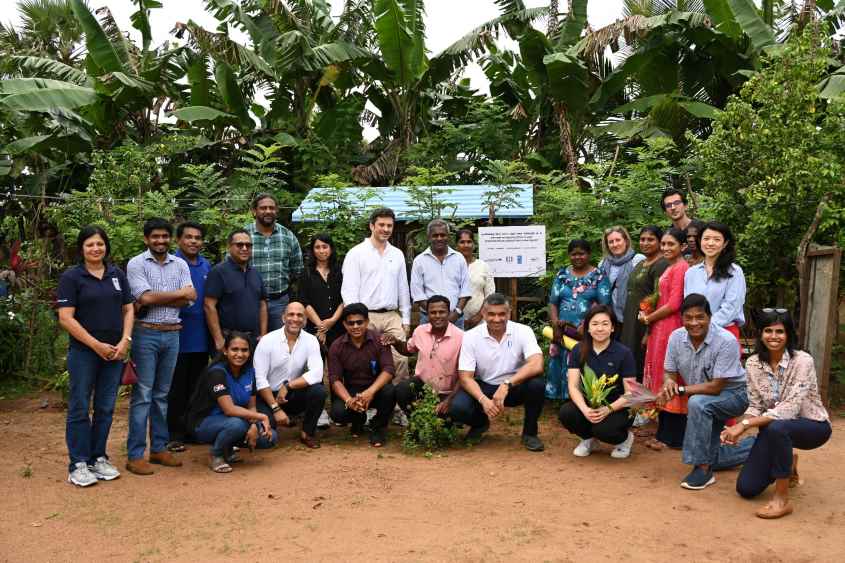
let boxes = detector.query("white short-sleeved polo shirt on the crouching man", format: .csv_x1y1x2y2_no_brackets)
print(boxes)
458,321,542,385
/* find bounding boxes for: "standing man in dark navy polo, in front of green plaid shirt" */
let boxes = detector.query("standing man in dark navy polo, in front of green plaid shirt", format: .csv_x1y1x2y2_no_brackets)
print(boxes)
204,229,267,350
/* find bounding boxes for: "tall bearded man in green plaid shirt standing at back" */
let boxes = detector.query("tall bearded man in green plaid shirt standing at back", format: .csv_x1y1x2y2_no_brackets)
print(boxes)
246,193,303,331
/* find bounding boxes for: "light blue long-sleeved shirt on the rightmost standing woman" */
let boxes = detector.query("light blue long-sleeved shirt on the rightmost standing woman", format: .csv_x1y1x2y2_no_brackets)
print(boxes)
684,262,745,326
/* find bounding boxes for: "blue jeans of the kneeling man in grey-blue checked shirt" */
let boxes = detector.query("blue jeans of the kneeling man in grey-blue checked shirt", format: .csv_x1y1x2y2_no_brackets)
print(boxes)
683,385,751,469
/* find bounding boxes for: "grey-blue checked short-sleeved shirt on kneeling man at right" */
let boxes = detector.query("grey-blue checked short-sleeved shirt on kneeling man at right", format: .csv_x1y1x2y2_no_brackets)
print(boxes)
663,322,745,388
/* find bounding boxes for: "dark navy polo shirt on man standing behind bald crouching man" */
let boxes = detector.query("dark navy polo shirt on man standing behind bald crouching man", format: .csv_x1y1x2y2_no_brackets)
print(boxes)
205,258,267,335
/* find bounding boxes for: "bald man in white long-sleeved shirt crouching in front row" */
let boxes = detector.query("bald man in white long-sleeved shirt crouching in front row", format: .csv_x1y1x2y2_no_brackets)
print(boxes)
252,301,326,448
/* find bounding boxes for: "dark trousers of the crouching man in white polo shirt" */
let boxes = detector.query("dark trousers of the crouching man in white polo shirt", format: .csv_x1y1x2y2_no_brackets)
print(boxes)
449,376,546,436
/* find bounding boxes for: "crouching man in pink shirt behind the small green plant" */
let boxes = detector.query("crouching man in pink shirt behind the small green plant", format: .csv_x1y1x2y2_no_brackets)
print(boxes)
382,295,464,416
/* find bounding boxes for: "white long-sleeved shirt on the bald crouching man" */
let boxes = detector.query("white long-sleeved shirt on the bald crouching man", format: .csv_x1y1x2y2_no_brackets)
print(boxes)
252,327,323,393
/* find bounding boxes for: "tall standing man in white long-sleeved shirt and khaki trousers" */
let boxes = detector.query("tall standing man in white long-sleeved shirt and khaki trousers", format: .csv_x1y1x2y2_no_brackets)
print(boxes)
340,208,411,381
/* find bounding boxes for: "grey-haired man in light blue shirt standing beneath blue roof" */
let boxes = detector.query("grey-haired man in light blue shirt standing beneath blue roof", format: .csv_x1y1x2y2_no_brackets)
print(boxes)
411,219,472,329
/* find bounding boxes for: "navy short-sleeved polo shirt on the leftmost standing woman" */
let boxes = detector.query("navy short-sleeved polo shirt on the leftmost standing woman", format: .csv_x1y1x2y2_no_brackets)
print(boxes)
56,264,134,348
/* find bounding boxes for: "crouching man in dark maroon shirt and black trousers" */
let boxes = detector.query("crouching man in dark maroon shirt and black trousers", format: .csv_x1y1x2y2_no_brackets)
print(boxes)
329,303,396,448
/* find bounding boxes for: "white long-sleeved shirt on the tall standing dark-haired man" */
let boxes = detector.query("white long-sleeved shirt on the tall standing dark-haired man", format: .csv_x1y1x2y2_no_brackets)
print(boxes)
340,239,411,325
